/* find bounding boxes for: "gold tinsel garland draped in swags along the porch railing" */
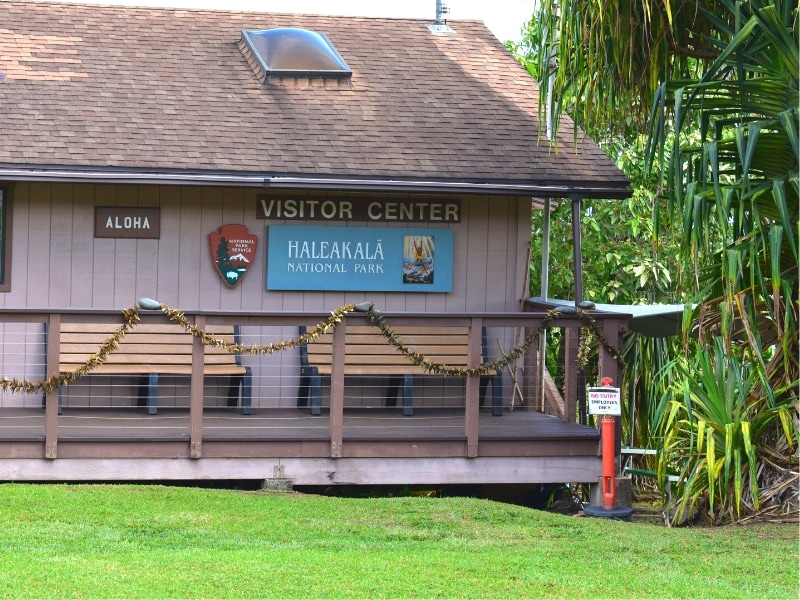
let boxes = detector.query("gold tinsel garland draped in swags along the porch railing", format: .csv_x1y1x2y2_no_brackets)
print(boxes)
0,298,623,394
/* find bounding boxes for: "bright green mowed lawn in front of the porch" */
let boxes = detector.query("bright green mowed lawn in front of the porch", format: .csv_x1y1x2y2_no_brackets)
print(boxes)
0,484,799,599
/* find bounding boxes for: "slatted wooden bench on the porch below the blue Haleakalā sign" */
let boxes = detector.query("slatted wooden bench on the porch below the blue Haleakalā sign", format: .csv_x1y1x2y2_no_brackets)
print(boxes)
297,325,503,416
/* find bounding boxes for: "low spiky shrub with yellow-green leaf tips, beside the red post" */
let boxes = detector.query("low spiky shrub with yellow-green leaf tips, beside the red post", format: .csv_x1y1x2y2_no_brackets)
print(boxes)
658,338,798,522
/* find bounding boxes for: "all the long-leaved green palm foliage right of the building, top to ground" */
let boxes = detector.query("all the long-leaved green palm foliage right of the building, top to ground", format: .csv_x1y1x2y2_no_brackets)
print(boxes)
525,0,800,520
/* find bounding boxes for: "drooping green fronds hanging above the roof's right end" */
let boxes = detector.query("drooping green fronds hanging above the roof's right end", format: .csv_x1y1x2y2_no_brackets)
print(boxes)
524,0,733,141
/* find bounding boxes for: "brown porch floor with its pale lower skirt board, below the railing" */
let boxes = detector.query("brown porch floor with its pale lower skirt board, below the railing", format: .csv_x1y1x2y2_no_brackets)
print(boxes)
0,408,600,485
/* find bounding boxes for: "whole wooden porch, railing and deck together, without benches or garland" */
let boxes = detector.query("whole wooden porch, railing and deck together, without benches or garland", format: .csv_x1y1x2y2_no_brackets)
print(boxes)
0,311,622,486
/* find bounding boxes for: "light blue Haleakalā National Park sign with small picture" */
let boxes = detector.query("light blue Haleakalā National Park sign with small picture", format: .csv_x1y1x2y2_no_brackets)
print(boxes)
266,225,453,293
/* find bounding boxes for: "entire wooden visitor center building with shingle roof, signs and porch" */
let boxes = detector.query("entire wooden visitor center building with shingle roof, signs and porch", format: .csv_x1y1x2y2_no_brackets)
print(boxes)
0,1,630,486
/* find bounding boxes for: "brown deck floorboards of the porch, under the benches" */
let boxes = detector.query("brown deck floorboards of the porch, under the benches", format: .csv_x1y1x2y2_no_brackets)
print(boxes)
0,408,600,442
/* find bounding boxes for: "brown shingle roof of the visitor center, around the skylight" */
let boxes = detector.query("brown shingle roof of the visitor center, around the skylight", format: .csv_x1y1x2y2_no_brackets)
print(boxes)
0,1,627,197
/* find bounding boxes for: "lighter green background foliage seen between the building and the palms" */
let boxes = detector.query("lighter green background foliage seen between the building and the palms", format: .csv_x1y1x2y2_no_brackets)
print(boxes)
509,22,685,450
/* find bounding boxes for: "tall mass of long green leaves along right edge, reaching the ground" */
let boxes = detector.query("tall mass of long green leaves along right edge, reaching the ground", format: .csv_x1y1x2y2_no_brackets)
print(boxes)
651,0,800,518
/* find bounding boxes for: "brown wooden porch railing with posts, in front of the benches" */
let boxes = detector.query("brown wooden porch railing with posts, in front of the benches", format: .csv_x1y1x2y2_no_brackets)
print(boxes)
0,308,625,458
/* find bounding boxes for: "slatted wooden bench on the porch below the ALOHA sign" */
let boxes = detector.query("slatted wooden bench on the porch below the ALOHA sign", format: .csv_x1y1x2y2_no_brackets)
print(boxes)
58,322,252,415
